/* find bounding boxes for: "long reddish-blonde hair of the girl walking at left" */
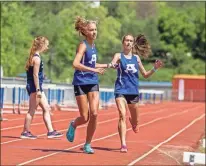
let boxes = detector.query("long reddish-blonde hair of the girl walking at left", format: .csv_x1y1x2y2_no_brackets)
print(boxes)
25,36,48,70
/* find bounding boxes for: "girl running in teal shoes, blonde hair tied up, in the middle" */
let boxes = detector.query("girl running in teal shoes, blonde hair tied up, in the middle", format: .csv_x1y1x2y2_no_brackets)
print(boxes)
67,17,112,154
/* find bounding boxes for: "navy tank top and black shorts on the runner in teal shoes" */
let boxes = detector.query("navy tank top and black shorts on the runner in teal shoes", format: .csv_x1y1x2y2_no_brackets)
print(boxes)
72,40,99,96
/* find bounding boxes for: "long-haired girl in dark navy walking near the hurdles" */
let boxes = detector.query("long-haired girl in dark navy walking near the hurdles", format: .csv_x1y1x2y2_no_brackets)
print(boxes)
20,36,63,139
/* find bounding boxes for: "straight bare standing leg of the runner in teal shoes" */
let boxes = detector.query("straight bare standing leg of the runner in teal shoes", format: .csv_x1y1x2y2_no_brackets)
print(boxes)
86,91,99,144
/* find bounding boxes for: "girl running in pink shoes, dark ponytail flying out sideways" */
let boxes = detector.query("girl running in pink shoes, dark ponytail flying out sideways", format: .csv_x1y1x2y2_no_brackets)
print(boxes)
112,35,162,152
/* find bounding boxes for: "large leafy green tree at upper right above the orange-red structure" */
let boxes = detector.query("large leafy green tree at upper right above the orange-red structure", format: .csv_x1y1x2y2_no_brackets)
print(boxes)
158,1,205,73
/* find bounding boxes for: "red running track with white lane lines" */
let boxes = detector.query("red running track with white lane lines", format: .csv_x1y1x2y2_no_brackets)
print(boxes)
1,102,205,165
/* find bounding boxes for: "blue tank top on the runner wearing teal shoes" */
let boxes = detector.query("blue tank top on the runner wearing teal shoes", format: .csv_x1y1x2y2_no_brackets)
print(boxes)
72,40,99,85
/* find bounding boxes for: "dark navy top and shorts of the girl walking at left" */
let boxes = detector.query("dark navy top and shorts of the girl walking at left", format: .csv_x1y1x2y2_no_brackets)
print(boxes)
26,54,44,95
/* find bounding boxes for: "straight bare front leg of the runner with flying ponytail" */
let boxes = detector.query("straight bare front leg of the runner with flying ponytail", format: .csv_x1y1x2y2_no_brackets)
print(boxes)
116,97,127,146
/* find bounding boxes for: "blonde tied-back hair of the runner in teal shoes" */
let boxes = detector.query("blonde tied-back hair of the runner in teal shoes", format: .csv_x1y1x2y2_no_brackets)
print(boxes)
75,16,98,37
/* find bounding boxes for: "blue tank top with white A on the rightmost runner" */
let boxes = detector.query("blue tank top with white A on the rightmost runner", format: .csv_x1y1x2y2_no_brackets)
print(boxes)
114,53,139,95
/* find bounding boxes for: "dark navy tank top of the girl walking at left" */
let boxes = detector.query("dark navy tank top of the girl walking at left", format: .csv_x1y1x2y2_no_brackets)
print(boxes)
26,54,44,85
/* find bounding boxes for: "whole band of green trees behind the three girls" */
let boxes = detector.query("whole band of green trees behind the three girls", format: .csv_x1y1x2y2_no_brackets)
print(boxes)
1,1,206,86
